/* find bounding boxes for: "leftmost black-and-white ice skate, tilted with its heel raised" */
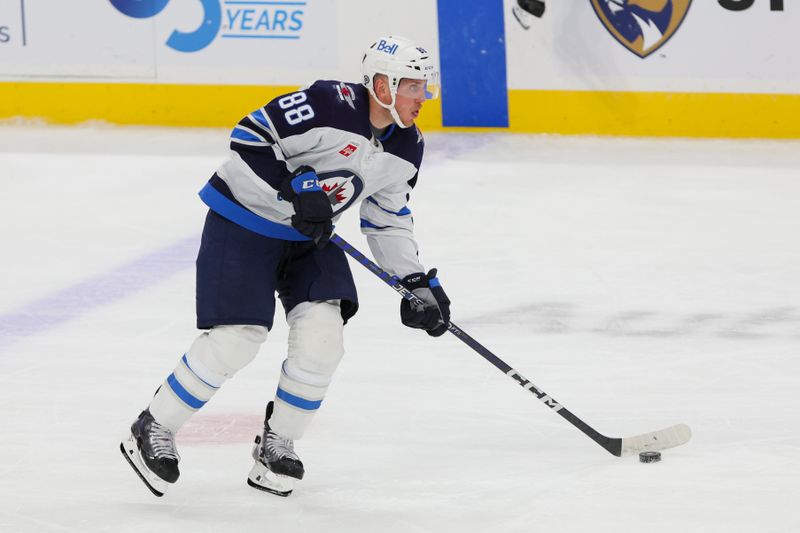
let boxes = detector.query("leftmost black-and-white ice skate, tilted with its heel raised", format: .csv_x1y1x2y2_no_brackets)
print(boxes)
119,409,181,497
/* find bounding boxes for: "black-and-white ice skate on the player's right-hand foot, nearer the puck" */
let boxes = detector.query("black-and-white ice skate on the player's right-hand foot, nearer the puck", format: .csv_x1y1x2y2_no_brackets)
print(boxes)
247,402,305,496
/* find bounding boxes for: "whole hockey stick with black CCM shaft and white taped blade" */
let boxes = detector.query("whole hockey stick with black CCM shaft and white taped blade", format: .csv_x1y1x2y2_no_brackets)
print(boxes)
331,234,692,457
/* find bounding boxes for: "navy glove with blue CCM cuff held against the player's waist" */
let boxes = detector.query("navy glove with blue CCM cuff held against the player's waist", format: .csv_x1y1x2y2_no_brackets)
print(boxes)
281,165,333,248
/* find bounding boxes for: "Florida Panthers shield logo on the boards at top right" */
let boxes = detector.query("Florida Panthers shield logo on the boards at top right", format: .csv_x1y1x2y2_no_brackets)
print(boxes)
590,0,692,58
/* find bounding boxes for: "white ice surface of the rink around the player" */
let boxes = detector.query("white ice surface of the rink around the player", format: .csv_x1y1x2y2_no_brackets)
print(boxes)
0,125,800,533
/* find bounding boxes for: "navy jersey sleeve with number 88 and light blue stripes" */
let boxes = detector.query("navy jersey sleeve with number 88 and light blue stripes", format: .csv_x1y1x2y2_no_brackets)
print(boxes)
230,85,330,190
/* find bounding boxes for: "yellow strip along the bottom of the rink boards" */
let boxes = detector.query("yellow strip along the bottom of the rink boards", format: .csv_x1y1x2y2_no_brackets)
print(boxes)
0,82,800,139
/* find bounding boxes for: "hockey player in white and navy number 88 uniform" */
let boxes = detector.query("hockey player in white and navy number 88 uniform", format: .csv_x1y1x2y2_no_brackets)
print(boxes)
120,37,450,496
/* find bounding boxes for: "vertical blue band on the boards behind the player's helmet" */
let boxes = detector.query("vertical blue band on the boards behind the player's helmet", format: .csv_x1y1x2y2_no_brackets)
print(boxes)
438,0,508,128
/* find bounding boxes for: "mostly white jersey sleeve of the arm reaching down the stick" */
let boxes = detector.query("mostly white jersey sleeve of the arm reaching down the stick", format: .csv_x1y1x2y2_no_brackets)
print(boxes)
360,172,424,278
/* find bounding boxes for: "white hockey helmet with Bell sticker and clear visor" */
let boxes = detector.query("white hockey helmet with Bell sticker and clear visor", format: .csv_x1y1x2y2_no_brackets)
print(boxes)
361,35,439,128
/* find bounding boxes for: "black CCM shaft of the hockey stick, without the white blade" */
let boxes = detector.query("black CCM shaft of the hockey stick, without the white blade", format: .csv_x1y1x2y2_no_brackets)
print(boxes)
331,234,622,456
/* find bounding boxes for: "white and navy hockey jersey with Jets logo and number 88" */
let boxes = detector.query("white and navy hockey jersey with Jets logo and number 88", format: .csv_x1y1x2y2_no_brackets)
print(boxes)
200,80,425,278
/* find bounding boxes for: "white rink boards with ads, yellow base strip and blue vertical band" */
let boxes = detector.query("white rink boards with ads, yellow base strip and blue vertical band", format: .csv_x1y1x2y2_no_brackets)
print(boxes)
0,0,800,138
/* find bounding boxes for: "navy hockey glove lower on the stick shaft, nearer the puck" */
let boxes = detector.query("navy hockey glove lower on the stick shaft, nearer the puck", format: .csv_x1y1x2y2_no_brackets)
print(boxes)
400,268,450,337
